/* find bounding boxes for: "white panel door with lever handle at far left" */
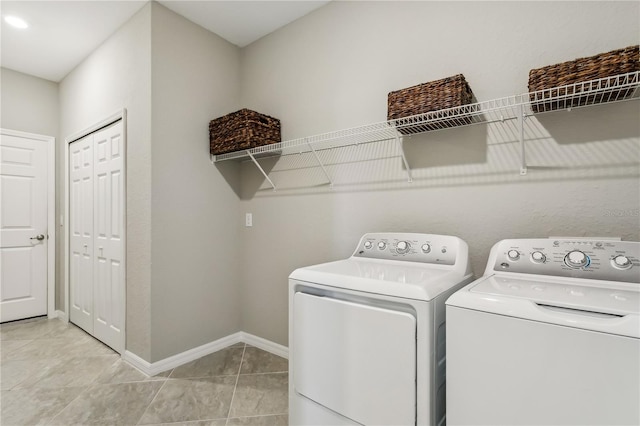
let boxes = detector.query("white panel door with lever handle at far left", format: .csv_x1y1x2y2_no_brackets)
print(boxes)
0,134,48,322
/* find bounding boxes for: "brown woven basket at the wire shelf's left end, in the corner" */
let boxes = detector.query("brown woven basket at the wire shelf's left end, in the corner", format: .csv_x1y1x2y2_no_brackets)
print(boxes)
209,108,280,155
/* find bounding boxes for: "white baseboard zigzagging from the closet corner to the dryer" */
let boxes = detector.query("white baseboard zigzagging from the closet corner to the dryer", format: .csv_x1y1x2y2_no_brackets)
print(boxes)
122,331,289,376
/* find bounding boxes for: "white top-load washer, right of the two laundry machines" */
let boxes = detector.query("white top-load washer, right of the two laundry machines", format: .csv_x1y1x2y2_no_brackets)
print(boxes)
446,239,640,425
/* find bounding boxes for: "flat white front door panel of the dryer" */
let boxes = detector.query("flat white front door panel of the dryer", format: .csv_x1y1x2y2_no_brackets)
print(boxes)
292,292,416,425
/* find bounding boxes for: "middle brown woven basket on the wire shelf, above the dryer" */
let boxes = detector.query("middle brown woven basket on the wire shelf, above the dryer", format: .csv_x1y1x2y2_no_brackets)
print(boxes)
387,74,473,134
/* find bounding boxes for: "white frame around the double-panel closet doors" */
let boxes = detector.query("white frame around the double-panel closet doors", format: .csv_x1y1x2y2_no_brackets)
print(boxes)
64,108,127,353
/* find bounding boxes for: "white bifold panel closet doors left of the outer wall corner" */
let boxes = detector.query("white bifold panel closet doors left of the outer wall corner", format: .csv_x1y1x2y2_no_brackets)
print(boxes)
69,122,125,352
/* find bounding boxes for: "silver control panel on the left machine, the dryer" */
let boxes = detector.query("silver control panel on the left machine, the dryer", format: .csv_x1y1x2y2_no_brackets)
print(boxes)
353,233,462,265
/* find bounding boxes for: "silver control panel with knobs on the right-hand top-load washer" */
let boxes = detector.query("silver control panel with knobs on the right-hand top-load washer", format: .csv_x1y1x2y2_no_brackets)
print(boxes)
487,238,640,284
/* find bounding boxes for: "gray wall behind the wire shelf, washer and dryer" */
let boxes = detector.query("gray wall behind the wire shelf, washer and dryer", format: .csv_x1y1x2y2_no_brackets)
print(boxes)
240,2,640,344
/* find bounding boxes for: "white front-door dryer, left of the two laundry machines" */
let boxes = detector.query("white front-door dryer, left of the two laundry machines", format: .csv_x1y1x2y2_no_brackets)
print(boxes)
289,233,472,425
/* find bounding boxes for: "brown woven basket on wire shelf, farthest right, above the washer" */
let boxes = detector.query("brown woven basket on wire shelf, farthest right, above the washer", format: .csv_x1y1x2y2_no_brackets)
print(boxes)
529,46,640,112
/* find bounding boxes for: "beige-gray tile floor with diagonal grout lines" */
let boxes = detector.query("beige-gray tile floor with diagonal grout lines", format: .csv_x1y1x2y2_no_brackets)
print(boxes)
0,318,288,426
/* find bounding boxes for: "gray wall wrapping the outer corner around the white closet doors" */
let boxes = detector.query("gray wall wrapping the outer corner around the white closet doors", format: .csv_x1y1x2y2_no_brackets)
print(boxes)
48,3,241,362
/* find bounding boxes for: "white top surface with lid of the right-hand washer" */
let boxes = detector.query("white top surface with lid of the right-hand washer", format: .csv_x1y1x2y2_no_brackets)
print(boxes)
447,275,640,338
